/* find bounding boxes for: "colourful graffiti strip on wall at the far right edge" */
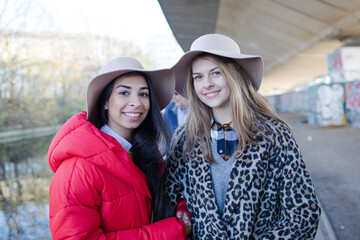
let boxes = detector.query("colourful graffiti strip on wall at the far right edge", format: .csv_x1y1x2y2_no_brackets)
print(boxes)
346,81,360,128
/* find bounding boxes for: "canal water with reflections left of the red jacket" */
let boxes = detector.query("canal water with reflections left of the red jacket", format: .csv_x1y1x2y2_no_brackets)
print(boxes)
0,136,53,240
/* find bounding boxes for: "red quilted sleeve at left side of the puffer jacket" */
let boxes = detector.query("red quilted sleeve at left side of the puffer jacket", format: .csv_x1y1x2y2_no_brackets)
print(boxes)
49,157,103,239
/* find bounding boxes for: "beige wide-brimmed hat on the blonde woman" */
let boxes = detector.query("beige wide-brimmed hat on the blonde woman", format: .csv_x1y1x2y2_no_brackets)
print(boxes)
172,33,264,97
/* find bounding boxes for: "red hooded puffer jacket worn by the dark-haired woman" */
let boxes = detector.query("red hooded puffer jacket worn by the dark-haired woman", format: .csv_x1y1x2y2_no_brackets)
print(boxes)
48,112,186,239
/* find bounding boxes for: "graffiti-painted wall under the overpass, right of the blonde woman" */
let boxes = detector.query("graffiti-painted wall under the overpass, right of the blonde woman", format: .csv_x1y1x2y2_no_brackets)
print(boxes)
267,81,360,128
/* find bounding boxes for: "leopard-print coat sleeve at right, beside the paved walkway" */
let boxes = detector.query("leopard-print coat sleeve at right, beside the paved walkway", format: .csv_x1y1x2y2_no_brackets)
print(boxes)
259,124,321,240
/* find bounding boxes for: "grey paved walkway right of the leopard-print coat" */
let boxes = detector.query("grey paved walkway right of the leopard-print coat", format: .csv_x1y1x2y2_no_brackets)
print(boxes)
280,114,360,240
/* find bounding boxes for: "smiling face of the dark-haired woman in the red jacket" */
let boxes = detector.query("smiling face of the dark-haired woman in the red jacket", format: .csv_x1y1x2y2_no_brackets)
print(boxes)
105,74,150,141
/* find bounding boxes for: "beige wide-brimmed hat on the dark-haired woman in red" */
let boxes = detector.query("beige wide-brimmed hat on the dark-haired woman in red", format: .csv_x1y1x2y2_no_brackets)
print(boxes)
86,57,175,123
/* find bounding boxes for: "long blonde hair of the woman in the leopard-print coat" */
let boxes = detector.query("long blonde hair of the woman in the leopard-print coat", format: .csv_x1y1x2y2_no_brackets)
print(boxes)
180,54,286,163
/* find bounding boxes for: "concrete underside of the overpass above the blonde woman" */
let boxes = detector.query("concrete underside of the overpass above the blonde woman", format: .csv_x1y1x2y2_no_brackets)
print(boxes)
158,0,360,95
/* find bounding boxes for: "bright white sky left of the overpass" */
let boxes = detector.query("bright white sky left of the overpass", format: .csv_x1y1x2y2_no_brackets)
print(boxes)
0,0,183,67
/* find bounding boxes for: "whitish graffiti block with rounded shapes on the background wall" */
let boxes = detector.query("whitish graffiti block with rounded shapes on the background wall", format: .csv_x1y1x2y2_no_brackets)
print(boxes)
316,83,346,126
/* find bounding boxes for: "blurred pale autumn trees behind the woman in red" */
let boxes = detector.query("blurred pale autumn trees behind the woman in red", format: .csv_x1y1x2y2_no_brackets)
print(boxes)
0,31,151,130
